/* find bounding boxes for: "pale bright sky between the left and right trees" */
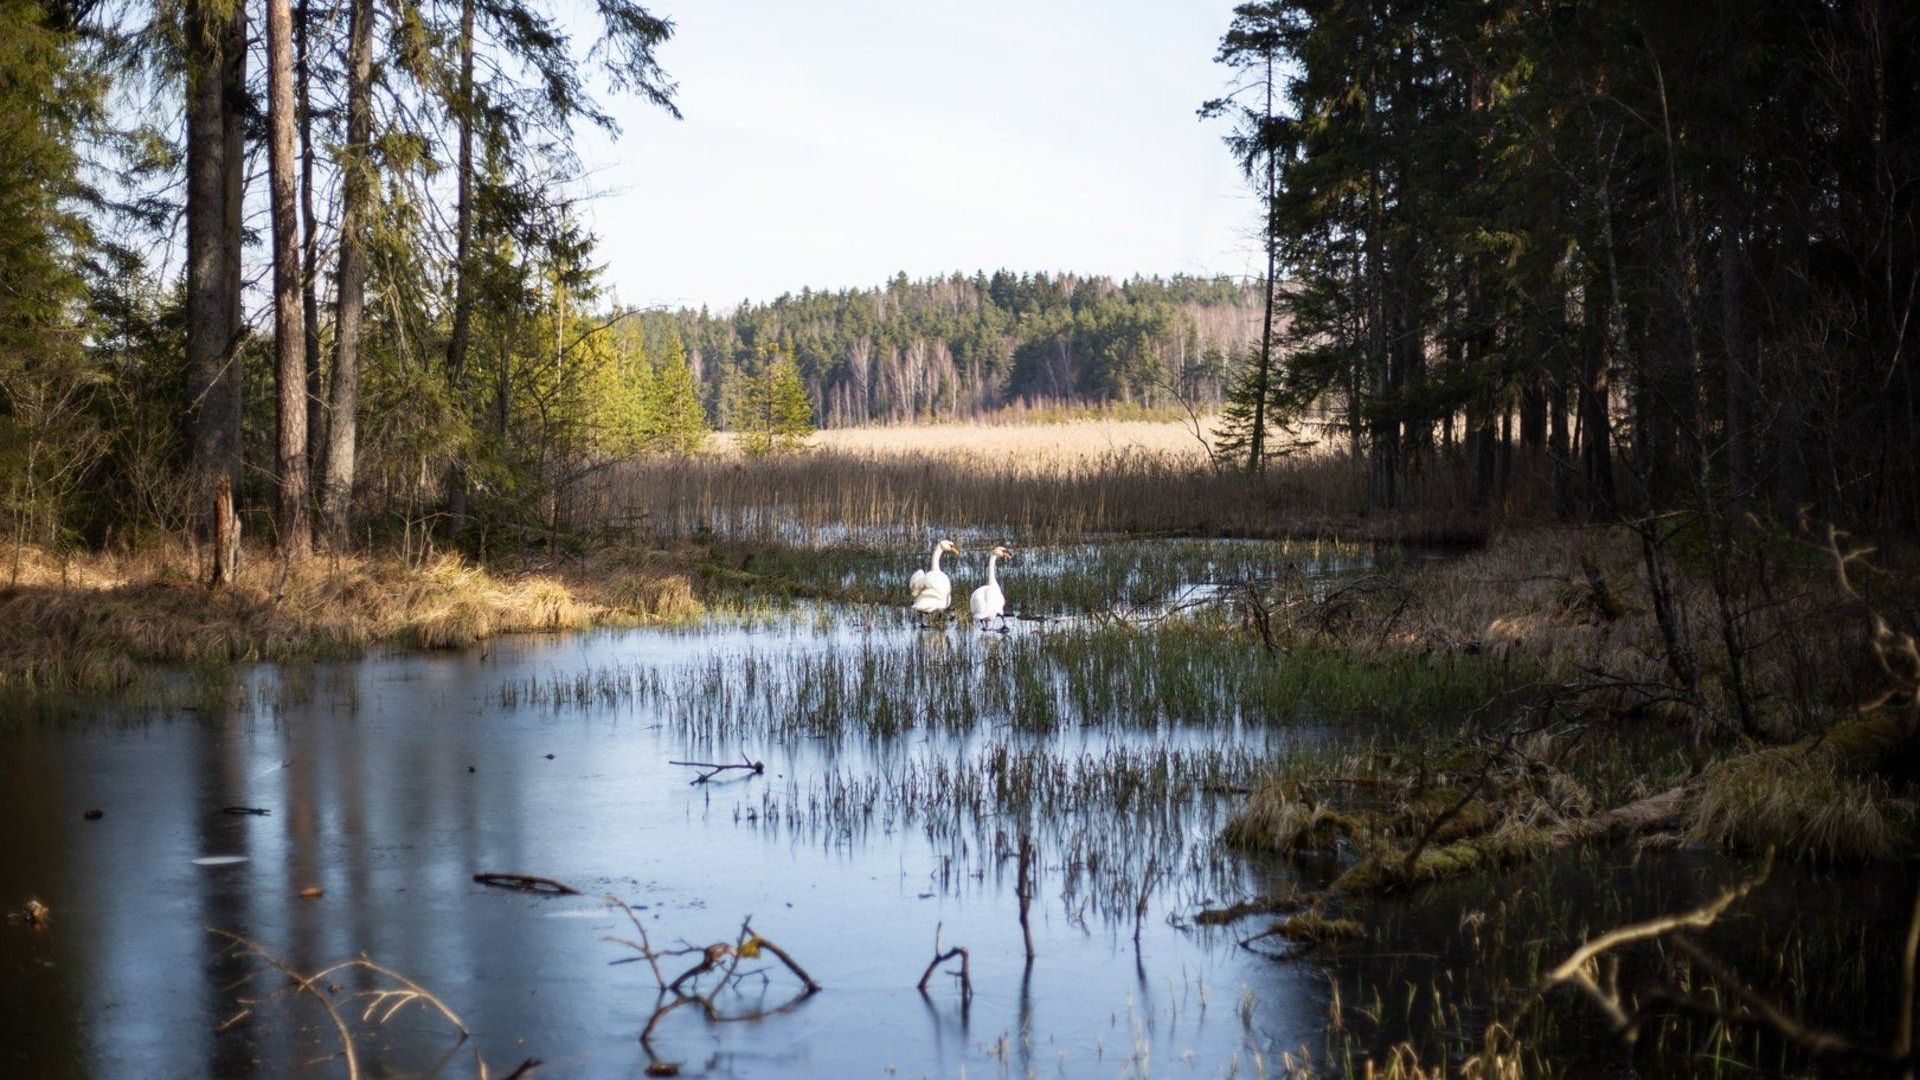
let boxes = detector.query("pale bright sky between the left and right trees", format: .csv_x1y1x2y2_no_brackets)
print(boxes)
574,0,1260,309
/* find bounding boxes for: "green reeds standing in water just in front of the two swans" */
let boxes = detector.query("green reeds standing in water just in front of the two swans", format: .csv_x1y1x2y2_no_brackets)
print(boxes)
499,619,1526,744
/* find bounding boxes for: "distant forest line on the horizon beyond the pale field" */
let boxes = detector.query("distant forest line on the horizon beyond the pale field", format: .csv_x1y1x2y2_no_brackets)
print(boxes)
630,269,1261,427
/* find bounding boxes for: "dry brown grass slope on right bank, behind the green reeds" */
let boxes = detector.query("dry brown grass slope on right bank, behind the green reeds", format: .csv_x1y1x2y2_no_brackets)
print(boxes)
1271,527,1868,738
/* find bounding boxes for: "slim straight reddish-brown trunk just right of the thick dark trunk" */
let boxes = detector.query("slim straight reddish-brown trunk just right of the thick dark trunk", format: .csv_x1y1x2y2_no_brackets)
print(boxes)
267,0,313,559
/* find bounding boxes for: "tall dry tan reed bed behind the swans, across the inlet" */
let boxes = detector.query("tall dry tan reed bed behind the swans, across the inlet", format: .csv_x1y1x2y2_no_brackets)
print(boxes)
568,440,1520,546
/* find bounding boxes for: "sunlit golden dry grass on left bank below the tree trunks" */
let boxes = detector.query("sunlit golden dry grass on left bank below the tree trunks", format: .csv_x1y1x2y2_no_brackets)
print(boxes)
0,548,697,692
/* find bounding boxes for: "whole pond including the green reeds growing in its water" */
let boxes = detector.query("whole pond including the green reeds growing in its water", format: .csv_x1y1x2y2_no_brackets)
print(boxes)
0,542,1907,1078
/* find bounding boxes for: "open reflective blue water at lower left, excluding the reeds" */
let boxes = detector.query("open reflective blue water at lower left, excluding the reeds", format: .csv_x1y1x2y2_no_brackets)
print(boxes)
0,621,1323,1078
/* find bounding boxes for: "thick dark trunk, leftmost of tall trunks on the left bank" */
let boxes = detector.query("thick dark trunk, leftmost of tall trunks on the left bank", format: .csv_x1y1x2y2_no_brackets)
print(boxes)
186,0,246,484
